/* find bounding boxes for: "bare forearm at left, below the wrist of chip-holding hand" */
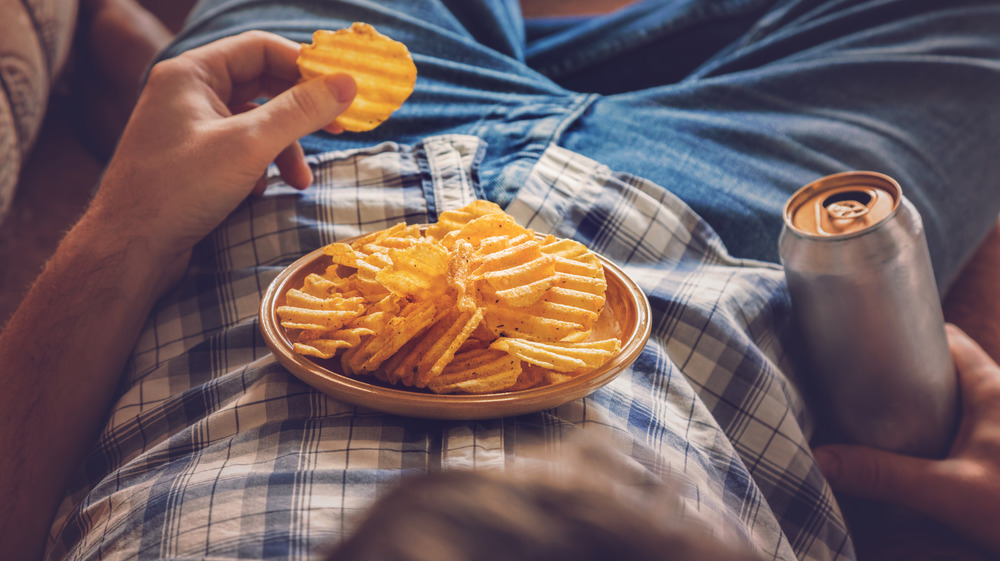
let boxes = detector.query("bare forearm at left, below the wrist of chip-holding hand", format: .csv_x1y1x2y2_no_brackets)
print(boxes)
0,213,163,560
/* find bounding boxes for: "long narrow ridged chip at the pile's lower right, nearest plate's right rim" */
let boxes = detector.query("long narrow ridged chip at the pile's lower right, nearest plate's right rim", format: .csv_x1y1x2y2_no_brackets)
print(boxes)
490,337,621,372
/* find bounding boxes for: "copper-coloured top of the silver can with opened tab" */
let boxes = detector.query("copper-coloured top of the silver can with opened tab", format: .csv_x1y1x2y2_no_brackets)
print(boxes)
785,171,903,238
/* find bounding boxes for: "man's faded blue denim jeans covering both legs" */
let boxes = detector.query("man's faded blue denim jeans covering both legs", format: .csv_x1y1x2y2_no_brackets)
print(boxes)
160,0,1000,288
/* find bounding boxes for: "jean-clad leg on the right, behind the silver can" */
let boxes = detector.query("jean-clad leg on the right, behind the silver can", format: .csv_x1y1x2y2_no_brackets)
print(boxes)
559,1,1000,289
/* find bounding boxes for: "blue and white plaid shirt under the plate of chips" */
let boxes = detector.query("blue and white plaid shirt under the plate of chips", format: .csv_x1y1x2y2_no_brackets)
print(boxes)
48,136,854,560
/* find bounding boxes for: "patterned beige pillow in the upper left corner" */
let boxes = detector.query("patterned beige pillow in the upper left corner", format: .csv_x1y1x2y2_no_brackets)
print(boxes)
0,0,77,220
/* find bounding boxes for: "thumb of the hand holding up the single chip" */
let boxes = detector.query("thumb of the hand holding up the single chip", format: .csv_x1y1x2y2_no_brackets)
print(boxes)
234,74,357,154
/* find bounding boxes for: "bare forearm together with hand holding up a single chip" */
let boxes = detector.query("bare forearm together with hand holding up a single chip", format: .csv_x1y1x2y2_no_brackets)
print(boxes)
0,32,355,560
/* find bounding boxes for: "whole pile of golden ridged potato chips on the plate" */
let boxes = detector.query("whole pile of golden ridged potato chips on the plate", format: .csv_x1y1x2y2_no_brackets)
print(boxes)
277,201,621,394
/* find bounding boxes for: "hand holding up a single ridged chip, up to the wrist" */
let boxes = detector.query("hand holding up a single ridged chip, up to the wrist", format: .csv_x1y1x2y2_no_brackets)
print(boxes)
89,31,356,284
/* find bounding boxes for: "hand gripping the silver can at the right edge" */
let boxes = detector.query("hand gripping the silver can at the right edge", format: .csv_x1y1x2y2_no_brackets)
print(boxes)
815,325,1000,554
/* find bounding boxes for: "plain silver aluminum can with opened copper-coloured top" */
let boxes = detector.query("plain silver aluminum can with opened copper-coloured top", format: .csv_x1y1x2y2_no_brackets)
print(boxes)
779,171,958,457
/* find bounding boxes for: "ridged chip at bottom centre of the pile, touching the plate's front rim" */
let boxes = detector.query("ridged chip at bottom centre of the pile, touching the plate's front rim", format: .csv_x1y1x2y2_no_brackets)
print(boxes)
427,349,521,394
